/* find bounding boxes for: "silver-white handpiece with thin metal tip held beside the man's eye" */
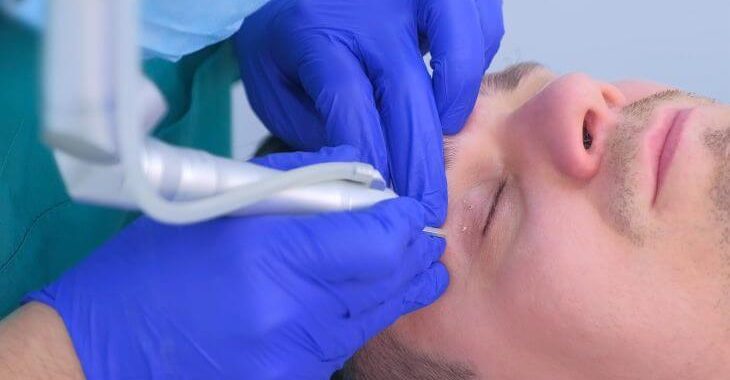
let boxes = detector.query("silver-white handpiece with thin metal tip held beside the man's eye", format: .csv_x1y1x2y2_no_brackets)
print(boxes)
55,140,445,238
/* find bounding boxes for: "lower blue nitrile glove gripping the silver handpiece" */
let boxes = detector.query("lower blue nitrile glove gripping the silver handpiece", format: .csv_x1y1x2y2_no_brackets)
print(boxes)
27,149,448,379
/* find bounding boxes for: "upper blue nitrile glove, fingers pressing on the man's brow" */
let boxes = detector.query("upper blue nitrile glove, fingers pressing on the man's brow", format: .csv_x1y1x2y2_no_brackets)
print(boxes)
234,0,504,226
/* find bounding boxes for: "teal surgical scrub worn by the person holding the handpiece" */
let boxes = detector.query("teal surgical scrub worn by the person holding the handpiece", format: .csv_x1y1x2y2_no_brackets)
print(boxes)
0,13,239,318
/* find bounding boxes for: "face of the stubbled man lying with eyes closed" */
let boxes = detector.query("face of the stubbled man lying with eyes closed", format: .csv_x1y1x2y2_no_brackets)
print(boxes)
356,64,730,379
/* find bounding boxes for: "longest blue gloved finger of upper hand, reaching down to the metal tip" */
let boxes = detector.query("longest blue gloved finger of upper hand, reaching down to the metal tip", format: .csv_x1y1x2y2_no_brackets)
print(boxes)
366,41,447,226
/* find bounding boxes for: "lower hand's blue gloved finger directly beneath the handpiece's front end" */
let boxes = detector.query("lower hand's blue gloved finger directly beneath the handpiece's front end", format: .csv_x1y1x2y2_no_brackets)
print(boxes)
280,197,425,282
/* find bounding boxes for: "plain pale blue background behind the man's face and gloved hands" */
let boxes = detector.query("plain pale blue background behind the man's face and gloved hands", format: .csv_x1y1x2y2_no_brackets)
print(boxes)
233,0,730,157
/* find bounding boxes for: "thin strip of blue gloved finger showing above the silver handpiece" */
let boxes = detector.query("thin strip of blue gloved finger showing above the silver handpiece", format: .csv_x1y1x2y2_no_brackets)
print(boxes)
250,145,360,170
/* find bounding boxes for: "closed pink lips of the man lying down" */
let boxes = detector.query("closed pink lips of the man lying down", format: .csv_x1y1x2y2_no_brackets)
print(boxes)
652,108,692,204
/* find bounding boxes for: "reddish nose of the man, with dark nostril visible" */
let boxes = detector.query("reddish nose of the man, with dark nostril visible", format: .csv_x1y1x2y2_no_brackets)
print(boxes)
508,73,625,181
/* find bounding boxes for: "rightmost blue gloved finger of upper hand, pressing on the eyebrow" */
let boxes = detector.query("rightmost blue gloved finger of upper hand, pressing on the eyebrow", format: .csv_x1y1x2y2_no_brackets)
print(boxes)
418,0,485,134
